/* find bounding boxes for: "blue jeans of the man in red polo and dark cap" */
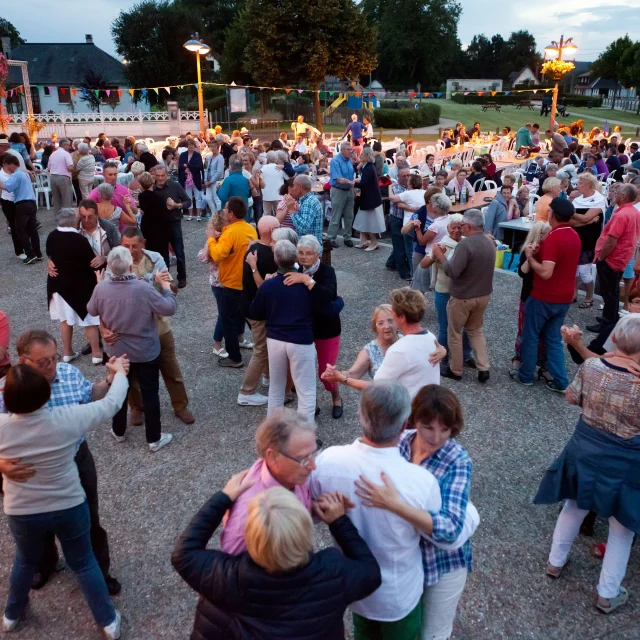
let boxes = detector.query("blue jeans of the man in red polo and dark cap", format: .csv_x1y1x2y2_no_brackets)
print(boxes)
519,296,569,389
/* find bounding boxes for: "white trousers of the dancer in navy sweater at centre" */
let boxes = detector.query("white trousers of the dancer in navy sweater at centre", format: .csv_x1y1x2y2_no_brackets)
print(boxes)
267,338,316,422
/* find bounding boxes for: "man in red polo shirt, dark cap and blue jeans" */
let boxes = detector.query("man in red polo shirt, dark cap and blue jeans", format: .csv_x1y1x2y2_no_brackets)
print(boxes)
510,198,581,393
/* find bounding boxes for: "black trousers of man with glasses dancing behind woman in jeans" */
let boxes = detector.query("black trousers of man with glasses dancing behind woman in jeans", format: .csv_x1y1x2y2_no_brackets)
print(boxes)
40,440,111,578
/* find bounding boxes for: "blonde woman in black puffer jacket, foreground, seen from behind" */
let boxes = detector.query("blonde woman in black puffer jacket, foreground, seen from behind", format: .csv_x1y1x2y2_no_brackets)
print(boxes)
171,471,381,640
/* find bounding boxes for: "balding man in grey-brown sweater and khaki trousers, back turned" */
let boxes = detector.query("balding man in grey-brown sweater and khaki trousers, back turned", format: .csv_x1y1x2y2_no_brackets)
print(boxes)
432,209,496,383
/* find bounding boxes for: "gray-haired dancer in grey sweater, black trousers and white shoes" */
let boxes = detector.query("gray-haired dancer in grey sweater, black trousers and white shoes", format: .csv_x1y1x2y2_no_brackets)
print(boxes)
87,247,177,453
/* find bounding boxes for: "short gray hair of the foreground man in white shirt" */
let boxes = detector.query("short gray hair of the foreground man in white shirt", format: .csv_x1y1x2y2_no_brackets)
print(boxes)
359,381,411,444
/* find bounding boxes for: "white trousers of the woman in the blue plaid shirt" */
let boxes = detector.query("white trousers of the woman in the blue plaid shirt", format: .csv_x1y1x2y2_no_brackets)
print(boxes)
420,567,468,640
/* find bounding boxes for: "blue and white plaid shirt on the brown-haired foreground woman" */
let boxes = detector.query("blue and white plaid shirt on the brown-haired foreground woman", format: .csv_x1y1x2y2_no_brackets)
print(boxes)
398,429,473,587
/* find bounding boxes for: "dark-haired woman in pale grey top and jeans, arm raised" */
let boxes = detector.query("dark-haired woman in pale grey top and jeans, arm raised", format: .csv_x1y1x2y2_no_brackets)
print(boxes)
0,358,129,638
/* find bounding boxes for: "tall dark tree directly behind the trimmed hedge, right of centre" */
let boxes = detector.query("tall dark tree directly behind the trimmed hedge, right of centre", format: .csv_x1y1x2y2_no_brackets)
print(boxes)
377,0,461,89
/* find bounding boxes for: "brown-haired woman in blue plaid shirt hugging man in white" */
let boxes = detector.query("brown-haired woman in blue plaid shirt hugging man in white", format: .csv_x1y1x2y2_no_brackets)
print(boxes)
356,384,478,640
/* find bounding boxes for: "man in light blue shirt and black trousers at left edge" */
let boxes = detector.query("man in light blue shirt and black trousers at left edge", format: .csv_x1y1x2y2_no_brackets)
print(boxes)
0,155,42,264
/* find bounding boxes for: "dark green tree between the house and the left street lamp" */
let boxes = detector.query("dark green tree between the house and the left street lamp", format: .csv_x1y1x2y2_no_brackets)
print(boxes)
111,0,214,102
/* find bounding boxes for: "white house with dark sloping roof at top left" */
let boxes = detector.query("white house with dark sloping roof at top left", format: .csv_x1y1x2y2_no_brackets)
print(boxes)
5,34,146,113
